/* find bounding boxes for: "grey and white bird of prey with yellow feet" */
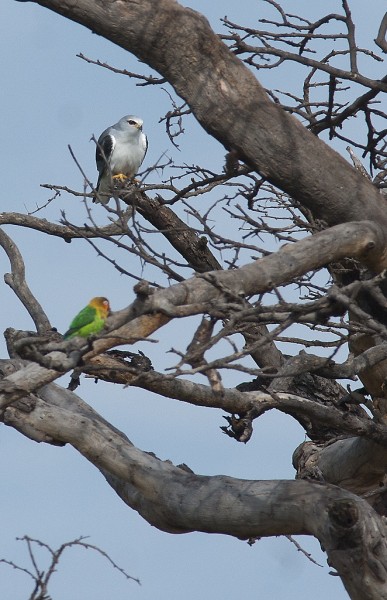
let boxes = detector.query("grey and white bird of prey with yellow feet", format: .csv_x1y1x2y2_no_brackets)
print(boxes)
94,115,148,204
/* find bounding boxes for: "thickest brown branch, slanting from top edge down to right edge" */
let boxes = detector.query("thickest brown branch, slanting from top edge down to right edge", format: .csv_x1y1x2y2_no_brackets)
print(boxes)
25,0,387,251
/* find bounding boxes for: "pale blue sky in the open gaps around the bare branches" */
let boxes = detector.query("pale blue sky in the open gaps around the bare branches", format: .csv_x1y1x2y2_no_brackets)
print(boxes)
0,0,385,600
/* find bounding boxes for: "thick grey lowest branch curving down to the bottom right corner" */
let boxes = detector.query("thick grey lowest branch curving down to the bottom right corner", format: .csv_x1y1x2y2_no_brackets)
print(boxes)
4,386,387,600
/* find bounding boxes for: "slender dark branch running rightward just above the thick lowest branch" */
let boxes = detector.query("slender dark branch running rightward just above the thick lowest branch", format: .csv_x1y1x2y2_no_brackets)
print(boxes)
87,354,387,446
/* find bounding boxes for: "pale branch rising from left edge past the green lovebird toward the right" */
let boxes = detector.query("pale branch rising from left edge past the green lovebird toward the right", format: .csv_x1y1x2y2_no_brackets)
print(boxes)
0,222,383,418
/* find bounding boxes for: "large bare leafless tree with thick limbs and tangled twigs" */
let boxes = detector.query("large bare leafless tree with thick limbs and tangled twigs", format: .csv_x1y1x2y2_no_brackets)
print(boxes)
4,0,387,600
